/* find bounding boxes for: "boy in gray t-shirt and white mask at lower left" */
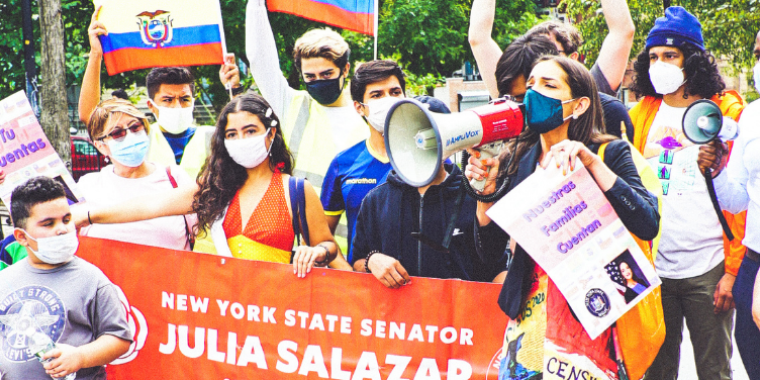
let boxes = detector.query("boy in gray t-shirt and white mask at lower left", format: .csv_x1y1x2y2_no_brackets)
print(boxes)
0,177,132,380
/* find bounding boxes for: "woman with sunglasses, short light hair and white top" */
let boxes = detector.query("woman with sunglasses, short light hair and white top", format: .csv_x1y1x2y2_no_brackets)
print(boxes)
79,98,197,250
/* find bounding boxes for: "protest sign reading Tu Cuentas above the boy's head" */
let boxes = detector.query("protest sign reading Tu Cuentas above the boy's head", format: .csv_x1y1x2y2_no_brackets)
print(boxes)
0,91,84,205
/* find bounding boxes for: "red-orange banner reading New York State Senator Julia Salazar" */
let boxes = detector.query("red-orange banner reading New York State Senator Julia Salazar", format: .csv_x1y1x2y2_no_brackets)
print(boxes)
78,237,507,380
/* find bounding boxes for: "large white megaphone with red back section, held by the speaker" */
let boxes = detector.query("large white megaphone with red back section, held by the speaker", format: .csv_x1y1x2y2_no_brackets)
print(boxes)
385,99,525,191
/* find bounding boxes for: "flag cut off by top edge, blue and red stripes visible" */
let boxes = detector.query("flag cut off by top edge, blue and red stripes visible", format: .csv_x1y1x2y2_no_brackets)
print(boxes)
267,0,378,35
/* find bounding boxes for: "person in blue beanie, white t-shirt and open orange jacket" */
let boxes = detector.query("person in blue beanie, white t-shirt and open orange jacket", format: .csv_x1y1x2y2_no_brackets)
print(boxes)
630,7,746,379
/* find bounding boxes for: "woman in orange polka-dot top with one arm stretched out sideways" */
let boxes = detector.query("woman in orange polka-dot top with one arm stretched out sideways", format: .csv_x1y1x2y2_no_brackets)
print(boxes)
78,94,338,277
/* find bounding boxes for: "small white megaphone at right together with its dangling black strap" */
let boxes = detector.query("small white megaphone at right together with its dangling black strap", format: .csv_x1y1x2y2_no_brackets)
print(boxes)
681,99,739,240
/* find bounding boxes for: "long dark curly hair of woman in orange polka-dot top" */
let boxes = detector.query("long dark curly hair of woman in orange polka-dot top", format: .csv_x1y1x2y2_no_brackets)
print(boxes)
193,94,295,235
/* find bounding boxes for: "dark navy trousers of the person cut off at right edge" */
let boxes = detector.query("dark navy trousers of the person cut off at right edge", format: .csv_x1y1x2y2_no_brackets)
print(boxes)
733,256,760,380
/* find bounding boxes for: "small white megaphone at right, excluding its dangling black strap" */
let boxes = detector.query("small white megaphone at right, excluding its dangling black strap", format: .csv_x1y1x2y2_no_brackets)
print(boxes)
682,99,739,144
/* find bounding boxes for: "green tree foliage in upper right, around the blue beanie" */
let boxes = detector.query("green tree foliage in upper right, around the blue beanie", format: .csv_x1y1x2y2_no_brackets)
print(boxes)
563,0,760,77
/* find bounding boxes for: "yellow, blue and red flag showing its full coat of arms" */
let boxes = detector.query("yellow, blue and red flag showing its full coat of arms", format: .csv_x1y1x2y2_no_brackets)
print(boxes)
97,0,226,75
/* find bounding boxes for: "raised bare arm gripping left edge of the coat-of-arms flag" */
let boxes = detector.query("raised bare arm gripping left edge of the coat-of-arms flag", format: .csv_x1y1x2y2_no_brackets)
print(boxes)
79,6,108,124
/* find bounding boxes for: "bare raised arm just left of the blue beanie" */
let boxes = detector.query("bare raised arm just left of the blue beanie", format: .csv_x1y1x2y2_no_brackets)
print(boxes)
596,0,636,91
